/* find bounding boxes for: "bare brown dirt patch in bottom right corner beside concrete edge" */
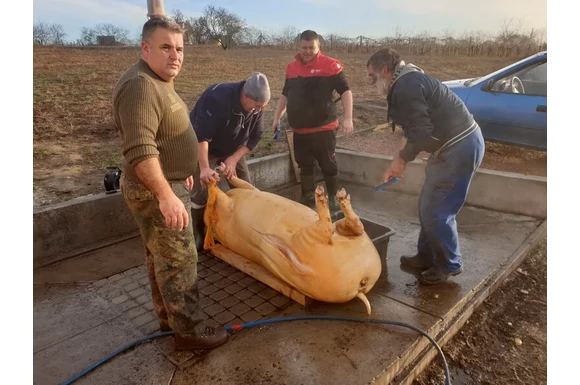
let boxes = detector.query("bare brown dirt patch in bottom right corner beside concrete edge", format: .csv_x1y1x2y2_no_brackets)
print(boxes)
414,240,548,385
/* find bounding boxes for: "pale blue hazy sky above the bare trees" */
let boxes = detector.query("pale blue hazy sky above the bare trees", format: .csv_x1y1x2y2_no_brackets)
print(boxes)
33,0,547,41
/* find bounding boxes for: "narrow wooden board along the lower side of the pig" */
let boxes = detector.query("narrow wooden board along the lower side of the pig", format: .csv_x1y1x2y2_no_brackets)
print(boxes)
210,245,315,307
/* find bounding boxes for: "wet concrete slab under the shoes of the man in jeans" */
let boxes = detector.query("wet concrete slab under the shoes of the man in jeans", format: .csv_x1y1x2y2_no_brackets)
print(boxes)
334,184,541,323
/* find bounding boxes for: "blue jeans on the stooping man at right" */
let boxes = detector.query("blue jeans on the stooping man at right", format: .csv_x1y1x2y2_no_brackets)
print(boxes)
417,128,485,272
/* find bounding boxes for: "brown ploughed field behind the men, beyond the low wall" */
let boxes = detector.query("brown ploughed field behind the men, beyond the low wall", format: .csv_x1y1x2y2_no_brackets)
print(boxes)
33,46,515,206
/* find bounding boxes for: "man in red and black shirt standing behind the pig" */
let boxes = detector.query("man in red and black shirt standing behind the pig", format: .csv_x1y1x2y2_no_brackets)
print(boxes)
273,30,353,211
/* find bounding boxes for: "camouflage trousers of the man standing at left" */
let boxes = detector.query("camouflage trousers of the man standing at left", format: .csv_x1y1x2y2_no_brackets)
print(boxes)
121,175,207,333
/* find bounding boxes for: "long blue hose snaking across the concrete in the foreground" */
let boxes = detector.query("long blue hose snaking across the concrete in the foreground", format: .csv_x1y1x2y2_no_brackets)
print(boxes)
60,315,451,385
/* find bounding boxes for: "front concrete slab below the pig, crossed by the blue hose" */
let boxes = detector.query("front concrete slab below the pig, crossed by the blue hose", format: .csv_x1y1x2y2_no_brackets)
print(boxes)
173,295,439,385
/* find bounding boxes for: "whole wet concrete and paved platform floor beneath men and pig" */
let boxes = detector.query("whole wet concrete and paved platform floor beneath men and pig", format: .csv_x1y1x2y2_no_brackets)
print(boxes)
34,184,545,385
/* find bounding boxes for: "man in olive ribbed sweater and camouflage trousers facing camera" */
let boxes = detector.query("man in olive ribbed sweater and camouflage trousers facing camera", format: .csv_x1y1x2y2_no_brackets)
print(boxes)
113,18,228,350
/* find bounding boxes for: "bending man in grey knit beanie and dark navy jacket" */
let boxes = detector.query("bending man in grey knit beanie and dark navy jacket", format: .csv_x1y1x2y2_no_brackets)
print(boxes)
190,72,270,250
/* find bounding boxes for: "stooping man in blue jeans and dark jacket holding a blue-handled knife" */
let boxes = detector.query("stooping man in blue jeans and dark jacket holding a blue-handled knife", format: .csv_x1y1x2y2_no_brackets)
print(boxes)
367,48,485,284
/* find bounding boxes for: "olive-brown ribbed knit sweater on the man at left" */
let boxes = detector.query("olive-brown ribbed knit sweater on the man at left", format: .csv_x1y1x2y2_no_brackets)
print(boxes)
113,59,198,181
